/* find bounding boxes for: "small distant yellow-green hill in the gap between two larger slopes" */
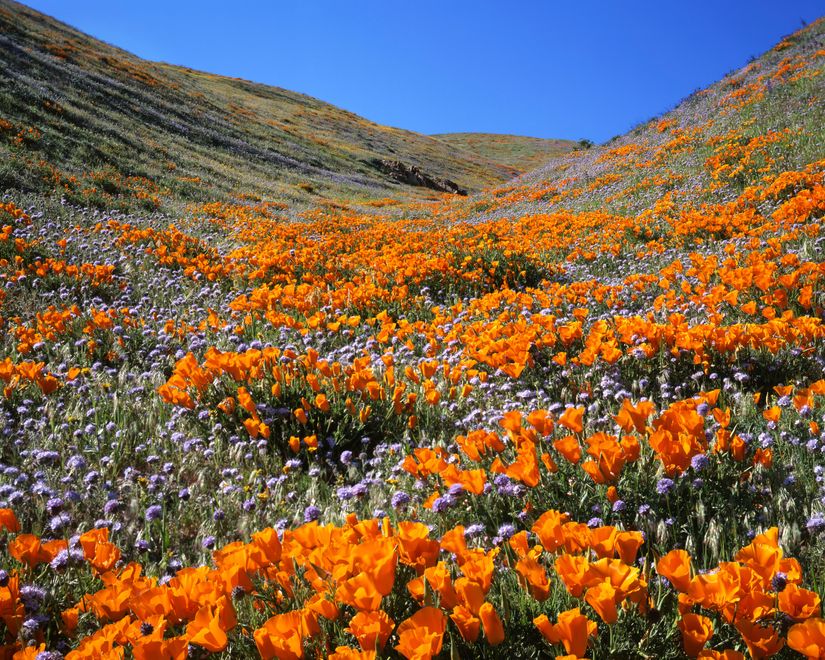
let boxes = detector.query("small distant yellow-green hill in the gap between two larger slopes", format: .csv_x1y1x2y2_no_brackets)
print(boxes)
433,133,577,173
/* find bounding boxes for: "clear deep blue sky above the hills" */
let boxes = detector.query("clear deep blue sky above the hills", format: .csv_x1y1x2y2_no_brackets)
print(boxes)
26,0,825,142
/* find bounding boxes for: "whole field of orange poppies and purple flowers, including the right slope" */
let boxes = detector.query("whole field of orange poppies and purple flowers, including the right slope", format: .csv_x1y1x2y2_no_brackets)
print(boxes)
0,7,825,660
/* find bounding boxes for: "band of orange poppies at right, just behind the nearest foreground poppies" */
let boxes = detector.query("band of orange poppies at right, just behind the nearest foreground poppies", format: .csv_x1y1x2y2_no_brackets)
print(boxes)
428,380,825,506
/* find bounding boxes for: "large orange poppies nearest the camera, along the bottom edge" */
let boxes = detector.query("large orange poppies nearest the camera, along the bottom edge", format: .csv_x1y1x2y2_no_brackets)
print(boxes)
0,500,825,660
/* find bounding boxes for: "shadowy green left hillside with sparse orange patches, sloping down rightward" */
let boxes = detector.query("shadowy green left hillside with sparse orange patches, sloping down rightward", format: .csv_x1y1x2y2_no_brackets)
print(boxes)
0,0,536,208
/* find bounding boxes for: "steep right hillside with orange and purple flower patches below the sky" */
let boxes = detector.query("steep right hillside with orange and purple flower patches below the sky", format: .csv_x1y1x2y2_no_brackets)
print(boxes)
444,19,825,221
